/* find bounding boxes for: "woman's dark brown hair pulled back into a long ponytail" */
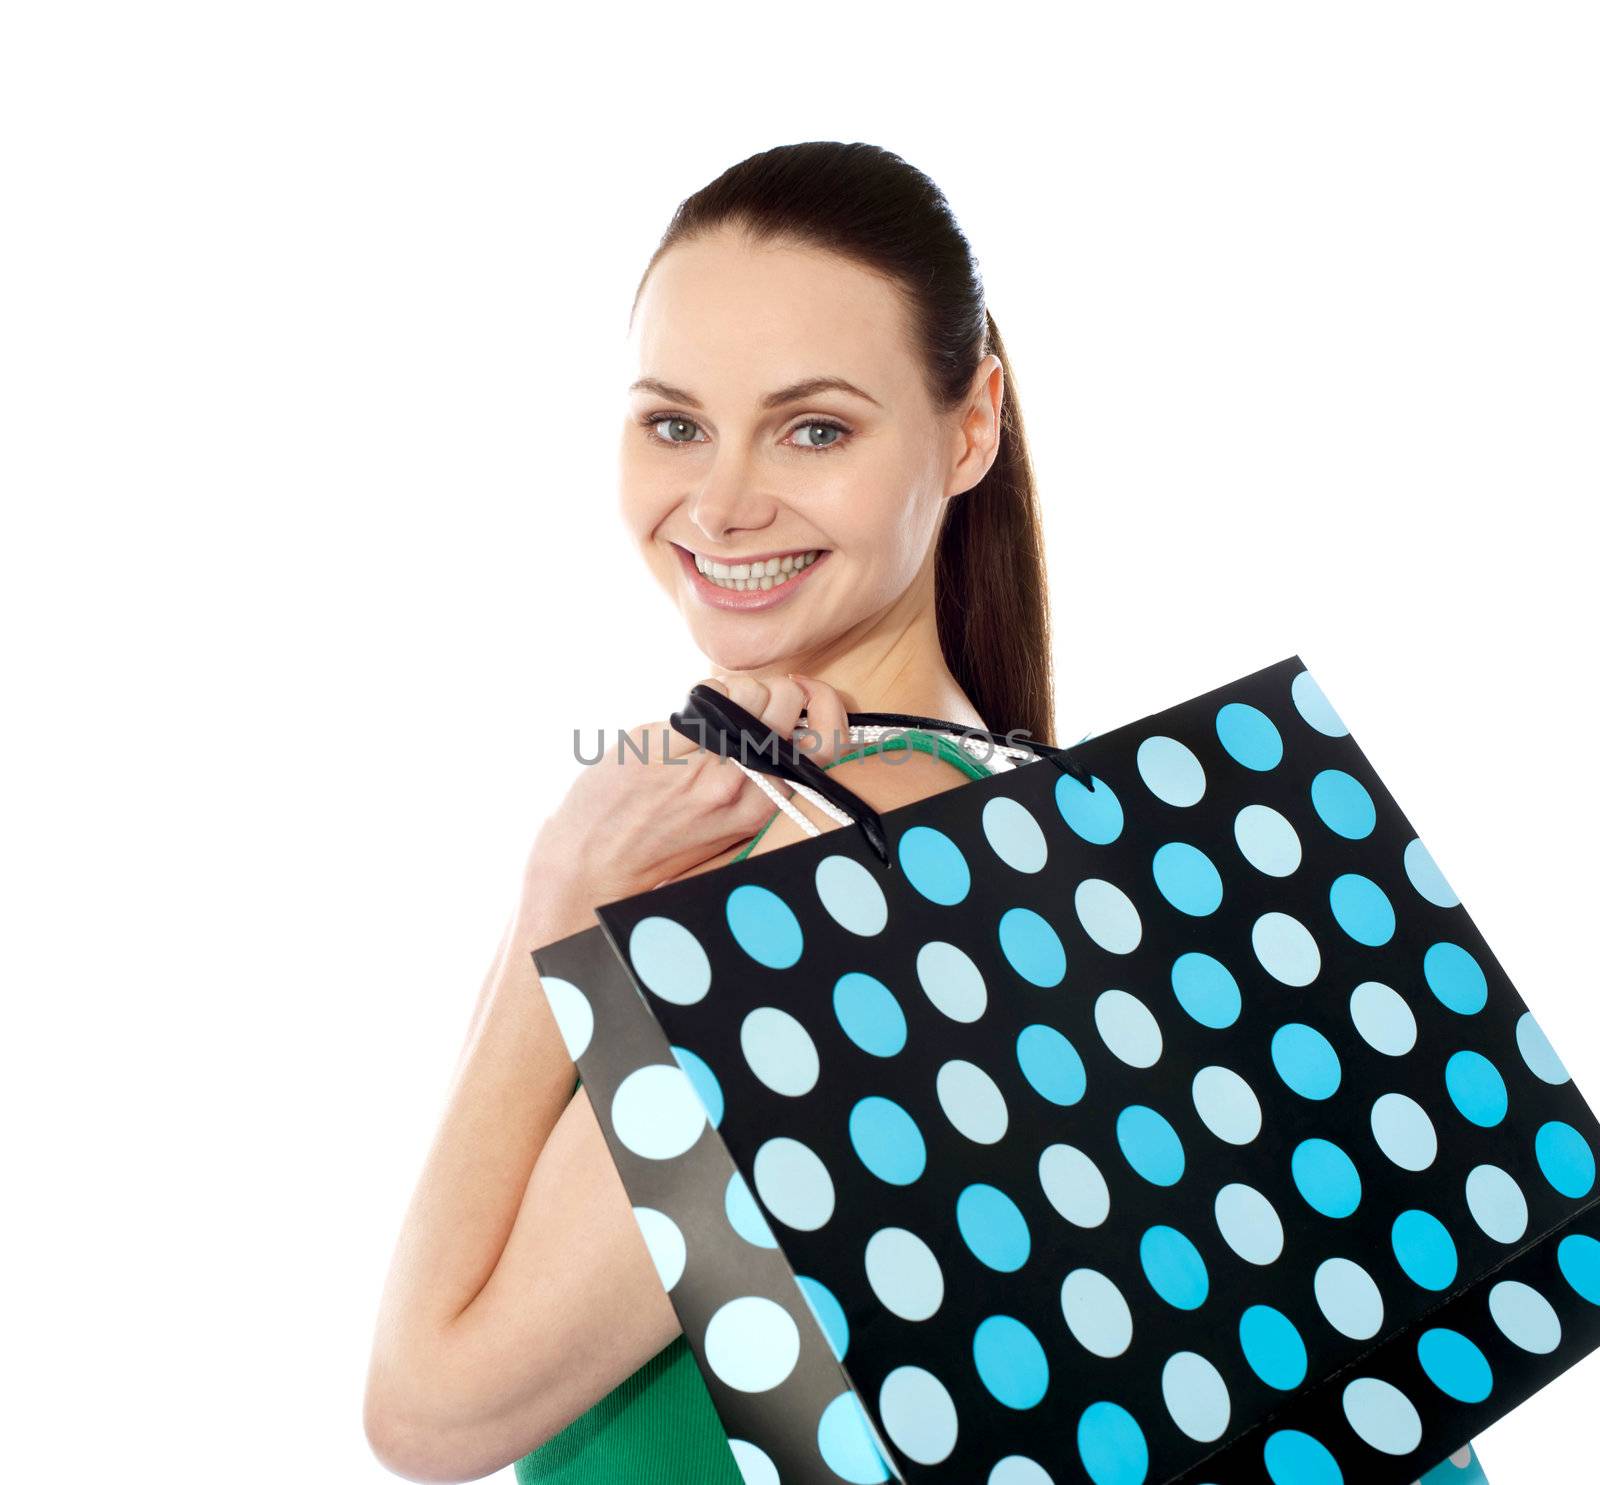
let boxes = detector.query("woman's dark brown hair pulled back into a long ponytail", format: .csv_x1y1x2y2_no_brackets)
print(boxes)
634,141,1054,743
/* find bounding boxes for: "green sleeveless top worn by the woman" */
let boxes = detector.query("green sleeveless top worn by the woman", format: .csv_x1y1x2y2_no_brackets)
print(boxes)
515,728,989,1485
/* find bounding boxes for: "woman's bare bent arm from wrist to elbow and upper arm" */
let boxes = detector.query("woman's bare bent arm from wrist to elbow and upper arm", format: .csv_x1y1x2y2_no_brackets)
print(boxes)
365,876,678,1482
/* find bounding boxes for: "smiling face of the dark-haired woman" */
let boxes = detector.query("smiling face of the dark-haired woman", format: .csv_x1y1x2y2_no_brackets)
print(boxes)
619,225,998,670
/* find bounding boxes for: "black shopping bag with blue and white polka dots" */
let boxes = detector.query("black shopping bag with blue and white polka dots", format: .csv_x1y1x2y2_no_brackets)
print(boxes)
533,656,1600,1485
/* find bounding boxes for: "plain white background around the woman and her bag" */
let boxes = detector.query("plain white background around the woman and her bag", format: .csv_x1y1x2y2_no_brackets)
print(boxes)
0,0,1600,1485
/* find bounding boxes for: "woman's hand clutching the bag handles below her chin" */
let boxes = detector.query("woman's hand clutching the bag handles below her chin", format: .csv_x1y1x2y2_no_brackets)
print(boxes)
523,675,850,936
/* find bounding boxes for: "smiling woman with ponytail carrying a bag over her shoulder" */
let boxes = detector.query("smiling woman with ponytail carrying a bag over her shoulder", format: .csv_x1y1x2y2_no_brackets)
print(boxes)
366,142,1053,1485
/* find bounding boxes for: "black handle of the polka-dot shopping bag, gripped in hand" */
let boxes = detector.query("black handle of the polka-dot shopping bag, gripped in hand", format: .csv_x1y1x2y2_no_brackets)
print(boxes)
669,683,1094,869
